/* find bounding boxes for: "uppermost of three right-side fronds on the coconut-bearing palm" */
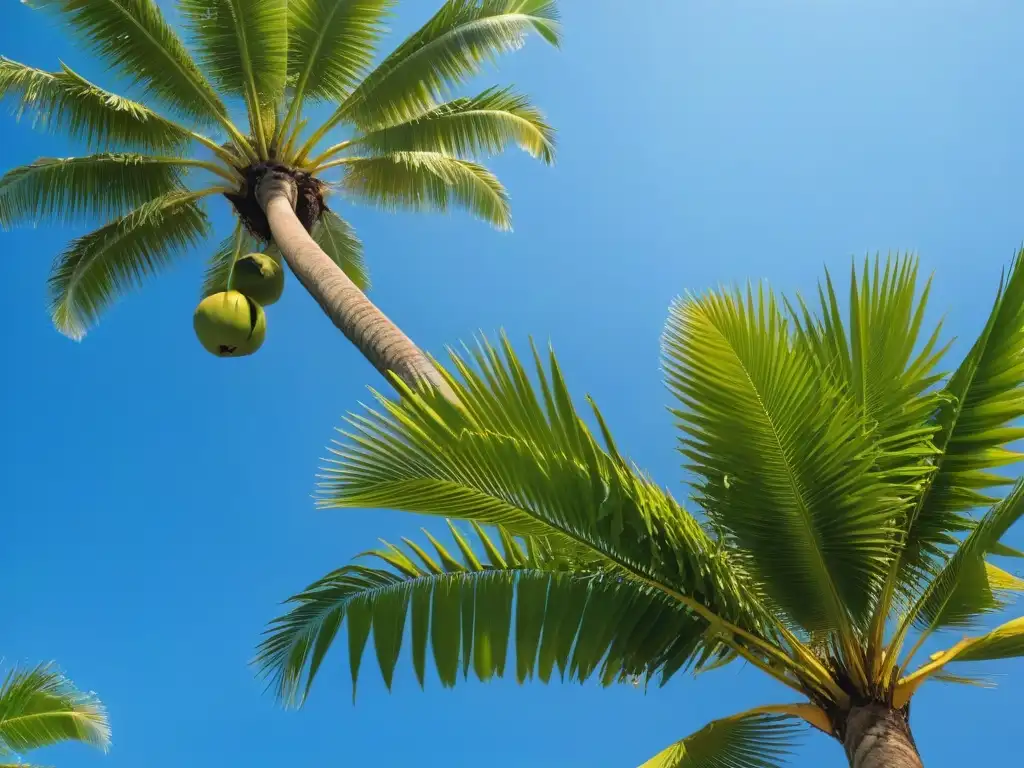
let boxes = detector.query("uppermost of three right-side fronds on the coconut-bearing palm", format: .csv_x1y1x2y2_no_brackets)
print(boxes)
338,0,559,129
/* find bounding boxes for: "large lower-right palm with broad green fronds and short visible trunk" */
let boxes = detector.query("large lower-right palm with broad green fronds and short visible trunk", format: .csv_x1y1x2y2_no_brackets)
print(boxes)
257,252,1024,768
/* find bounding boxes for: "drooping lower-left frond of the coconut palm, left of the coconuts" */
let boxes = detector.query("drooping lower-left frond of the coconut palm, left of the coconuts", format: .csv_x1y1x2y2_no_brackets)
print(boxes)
49,190,209,339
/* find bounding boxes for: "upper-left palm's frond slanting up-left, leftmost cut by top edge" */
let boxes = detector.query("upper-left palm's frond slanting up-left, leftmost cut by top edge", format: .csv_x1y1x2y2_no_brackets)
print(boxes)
29,0,227,124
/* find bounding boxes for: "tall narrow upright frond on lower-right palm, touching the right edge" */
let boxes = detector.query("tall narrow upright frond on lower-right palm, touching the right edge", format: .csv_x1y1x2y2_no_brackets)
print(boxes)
900,251,1024,591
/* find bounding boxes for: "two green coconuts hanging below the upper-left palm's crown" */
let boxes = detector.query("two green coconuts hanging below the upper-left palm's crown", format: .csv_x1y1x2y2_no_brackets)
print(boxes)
193,253,285,357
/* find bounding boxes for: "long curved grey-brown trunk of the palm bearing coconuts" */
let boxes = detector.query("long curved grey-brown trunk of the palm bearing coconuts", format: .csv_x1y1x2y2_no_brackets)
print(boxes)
256,171,455,399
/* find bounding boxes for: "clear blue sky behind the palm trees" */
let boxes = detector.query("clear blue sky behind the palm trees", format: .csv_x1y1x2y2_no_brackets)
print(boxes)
0,0,1024,768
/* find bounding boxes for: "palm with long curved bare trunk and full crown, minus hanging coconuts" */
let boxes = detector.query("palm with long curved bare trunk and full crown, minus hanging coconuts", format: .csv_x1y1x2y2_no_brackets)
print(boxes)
0,0,559,393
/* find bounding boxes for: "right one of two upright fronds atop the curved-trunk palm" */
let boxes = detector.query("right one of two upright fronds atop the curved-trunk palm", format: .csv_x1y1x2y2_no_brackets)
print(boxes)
288,0,394,100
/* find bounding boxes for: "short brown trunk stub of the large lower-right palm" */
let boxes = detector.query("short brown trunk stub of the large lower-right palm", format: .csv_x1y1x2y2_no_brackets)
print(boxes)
843,703,923,768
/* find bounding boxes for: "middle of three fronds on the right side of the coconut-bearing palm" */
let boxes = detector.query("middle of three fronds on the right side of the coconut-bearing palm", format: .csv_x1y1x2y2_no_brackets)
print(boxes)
352,88,555,163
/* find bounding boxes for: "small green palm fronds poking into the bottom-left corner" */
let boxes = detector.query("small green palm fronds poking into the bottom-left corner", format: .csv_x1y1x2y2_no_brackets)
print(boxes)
0,665,111,768
